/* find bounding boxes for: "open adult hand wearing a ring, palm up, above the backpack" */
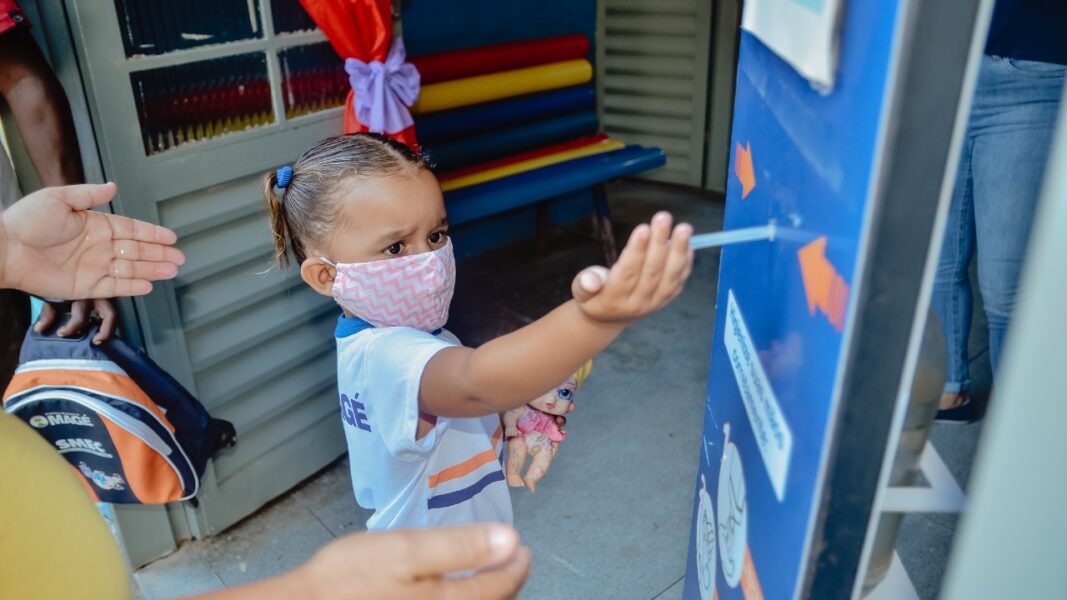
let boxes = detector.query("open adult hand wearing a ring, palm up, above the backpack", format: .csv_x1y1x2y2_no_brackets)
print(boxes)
0,184,185,300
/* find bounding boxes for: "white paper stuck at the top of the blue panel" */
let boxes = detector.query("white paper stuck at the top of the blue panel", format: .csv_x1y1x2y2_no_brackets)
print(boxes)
740,0,841,90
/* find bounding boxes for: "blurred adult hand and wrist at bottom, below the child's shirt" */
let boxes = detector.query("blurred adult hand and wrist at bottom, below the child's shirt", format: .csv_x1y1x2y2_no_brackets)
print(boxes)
198,524,530,600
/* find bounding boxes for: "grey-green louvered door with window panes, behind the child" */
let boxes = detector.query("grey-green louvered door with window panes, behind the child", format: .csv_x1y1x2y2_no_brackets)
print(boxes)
60,0,348,566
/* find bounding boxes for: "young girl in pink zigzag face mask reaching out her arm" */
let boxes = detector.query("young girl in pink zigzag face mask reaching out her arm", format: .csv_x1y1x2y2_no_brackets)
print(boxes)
265,133,692,531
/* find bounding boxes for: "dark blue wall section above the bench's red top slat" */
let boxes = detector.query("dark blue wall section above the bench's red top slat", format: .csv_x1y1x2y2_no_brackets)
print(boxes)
402,0,596,57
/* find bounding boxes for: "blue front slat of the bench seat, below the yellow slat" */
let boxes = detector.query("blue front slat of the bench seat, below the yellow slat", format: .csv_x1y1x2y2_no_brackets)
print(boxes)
445,145,667,225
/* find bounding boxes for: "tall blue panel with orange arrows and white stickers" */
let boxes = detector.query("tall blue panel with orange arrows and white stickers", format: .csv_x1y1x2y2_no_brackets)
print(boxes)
684,0,902,600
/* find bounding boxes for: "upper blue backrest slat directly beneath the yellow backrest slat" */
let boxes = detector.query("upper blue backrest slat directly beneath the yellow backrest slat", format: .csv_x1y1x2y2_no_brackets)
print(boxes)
415,85,596,147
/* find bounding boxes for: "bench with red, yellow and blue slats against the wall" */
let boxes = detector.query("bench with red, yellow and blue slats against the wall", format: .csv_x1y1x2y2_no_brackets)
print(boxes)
410,35,666,265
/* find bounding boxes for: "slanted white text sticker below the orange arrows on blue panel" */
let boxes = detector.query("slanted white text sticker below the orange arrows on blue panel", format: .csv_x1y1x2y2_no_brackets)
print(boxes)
719,290,793,499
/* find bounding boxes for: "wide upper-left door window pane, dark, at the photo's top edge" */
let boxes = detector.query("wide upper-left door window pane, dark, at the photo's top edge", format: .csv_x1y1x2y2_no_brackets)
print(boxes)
115,0,262,58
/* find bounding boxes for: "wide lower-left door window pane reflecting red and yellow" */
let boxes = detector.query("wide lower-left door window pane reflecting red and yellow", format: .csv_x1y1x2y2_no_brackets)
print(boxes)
130,52,274,155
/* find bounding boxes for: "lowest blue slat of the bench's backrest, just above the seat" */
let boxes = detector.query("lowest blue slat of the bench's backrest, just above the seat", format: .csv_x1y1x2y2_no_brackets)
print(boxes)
424,111,598,172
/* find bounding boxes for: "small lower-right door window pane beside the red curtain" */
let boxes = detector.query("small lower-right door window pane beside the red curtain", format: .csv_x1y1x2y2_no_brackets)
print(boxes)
277,42,349,119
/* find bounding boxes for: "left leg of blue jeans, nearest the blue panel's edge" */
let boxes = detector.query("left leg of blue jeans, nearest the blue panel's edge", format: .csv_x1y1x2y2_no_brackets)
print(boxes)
930,140,974,393
